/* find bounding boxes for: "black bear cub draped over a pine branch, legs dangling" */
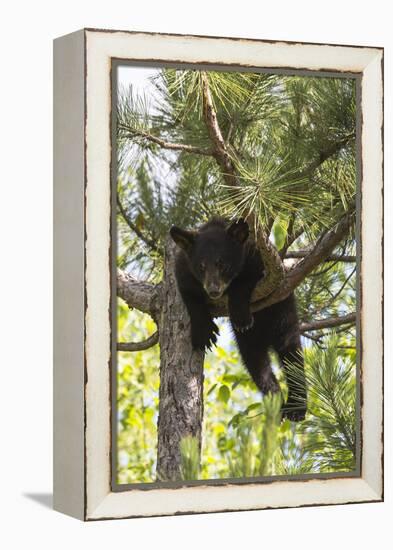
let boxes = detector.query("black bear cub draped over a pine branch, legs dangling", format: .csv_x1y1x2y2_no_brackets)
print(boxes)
170,218,306,421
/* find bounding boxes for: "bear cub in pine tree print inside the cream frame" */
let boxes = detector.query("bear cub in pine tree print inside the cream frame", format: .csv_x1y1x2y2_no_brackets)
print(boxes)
112,66,360,487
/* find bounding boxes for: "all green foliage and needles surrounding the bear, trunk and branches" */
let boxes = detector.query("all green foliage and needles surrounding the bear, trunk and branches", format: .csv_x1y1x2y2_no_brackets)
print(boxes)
117,69,356,483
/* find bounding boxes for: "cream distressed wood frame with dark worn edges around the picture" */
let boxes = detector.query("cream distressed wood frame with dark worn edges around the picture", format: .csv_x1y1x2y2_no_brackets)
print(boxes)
54,29,383,520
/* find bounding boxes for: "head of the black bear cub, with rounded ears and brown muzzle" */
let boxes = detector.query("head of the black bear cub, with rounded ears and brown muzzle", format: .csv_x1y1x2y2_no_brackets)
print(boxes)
170,219,249,300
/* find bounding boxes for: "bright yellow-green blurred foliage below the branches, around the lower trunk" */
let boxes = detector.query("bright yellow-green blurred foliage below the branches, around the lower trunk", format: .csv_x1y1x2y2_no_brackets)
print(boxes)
118,312,356,483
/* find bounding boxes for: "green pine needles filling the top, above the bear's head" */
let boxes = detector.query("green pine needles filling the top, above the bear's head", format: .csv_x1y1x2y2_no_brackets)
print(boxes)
118,69,356,265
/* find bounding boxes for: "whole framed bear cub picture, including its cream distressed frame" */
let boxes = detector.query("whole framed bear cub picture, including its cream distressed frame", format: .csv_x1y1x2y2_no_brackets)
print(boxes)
54,29,383,520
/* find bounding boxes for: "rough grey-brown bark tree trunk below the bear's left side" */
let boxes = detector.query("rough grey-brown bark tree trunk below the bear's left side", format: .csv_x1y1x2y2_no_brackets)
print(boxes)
157,240,204,481
